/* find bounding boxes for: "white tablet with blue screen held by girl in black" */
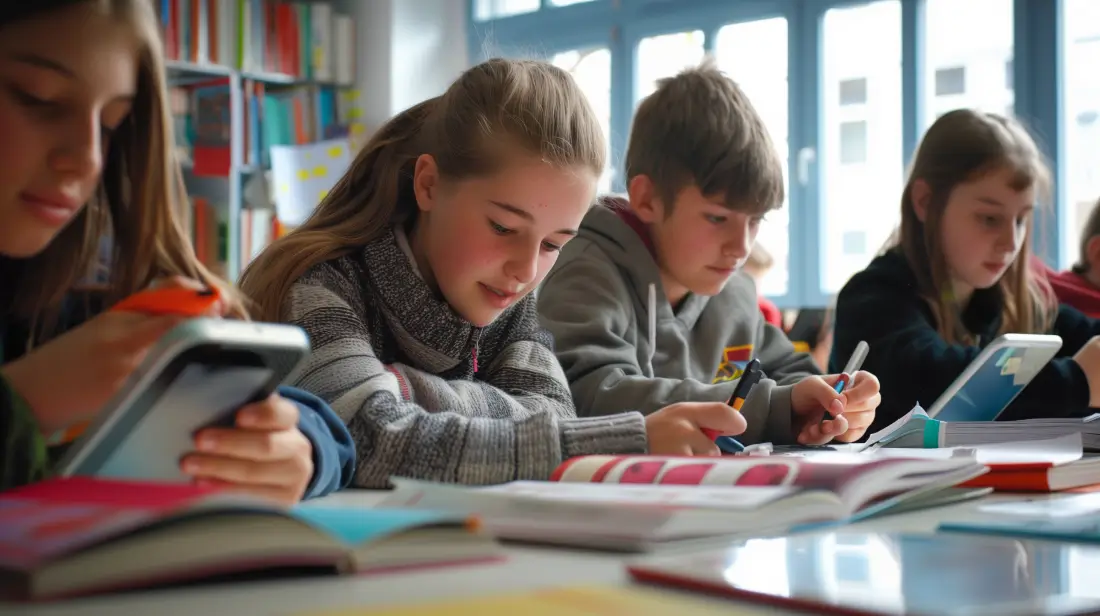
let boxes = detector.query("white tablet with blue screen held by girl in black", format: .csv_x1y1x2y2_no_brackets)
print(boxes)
913,333,1062,421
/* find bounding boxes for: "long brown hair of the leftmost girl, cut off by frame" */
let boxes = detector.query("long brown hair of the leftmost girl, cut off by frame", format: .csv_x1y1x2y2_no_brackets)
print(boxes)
0,0,244,338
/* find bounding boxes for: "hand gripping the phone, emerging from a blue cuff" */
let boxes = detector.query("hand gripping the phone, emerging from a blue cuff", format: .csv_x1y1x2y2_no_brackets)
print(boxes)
183,394,314,505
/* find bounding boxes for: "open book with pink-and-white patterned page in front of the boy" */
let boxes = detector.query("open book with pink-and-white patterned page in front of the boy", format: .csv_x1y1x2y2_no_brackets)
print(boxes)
381,454,989,551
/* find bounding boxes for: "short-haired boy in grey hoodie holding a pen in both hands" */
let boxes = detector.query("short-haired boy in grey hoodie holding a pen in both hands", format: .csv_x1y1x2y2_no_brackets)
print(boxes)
538,63,880,444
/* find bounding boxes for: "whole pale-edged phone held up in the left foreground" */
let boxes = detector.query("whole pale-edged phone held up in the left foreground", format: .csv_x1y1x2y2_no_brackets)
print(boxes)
58,318,310,481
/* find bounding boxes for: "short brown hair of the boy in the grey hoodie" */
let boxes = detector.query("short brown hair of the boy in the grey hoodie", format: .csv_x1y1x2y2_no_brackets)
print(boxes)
626,58,785,213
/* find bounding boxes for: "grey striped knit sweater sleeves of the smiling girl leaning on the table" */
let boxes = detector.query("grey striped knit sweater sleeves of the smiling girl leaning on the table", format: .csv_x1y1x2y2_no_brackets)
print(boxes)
287,283,647,487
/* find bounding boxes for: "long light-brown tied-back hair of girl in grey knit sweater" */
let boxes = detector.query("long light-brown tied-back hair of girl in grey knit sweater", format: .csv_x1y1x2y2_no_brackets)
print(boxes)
241,58,607,321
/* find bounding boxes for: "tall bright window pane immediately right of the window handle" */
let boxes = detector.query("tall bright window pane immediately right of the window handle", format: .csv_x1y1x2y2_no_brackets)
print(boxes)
820,0,902,294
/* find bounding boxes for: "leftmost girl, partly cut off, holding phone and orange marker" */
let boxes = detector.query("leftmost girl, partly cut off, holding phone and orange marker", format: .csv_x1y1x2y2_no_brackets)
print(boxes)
0,0,354,503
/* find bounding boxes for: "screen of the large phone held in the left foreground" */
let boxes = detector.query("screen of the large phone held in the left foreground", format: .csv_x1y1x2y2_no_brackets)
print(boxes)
77,353,273,480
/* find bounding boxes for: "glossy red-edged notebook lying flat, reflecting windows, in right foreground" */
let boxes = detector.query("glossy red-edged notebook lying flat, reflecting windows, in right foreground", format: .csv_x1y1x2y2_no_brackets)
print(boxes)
627,530,1100,616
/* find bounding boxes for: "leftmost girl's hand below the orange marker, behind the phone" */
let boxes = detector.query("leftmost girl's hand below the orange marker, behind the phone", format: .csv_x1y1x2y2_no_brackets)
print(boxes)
0,311,183,435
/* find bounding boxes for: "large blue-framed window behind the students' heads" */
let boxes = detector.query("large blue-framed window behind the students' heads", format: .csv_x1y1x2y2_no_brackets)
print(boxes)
469,0,1086,307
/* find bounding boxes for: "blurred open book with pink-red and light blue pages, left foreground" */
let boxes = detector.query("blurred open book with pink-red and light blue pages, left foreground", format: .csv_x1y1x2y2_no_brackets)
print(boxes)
0,477,498,601
